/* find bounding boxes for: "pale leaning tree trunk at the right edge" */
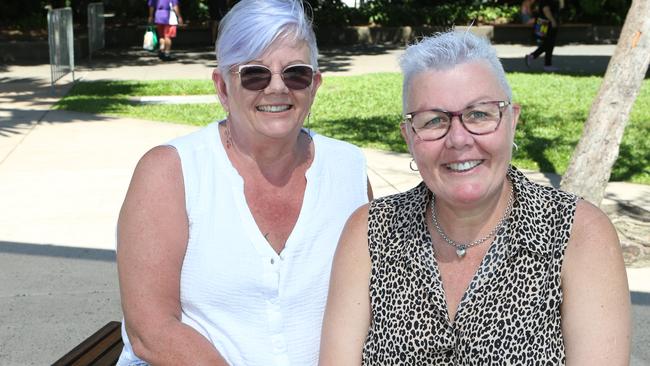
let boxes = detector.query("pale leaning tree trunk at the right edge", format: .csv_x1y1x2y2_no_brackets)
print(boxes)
560,0,650,205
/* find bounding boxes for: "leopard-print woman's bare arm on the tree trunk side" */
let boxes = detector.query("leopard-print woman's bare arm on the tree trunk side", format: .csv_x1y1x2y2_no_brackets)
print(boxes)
562,201,631,366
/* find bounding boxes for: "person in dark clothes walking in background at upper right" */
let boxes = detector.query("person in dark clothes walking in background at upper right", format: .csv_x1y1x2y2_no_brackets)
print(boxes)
524,0,563,72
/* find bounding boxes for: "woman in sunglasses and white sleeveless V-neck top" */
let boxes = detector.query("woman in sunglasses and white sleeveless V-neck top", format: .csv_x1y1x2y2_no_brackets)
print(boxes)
117,0,371,366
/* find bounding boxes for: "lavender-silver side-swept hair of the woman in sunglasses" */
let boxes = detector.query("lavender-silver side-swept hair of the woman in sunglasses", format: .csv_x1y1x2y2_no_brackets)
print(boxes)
215,0,318,74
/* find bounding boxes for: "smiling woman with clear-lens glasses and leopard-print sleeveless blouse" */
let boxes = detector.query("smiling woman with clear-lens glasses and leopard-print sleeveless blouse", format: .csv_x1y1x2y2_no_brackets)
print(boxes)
320,31,631,366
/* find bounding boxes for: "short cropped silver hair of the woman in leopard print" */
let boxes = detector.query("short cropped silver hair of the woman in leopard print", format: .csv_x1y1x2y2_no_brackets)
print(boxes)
399,30,512,113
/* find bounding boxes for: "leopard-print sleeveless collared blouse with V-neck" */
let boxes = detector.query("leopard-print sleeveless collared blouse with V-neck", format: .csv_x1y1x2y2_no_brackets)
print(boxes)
363,167,577,365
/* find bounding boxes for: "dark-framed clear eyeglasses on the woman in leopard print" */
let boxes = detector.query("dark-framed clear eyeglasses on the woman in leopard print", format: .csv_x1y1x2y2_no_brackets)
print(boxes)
404,101,511,141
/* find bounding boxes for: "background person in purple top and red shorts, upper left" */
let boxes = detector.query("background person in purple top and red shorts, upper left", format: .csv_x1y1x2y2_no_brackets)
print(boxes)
147,0,183,61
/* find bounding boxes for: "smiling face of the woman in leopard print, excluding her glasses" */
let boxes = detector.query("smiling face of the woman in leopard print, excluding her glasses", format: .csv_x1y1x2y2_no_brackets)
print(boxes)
402,62,519,206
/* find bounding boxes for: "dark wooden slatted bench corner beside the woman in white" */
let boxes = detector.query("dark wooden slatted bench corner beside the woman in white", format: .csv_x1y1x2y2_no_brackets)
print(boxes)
53,321,124,366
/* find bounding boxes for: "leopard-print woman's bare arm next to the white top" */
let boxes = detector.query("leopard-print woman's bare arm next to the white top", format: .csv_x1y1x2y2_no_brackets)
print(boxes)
319,205,370,366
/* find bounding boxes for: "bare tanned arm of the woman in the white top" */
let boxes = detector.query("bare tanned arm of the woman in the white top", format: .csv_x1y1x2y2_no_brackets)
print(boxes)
117,147,226,365
